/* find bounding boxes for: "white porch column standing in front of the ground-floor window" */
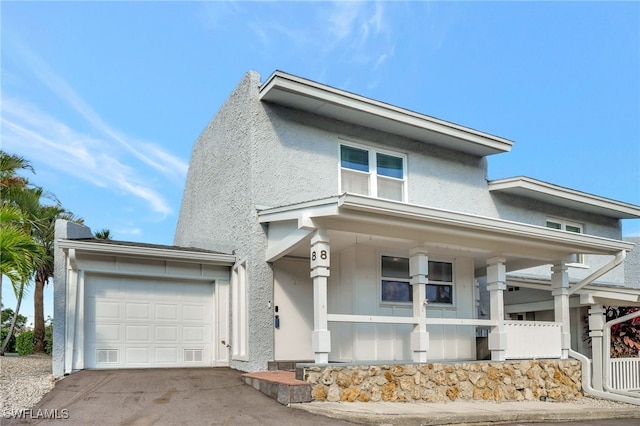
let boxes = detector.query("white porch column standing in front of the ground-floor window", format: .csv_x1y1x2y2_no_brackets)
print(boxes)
409,248,429,362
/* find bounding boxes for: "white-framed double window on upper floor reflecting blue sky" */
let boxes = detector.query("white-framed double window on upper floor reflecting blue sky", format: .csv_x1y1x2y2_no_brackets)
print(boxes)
340,145,406,201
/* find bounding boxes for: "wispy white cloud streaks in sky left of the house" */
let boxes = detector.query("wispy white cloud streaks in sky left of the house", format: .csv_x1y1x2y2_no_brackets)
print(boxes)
0,40,188,217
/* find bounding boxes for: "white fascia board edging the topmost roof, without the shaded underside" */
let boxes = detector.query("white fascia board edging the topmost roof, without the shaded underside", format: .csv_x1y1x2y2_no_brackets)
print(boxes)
259,71,514,153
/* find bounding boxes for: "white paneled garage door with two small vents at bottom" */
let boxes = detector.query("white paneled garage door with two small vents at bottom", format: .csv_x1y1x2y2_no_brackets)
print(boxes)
85,276,214,368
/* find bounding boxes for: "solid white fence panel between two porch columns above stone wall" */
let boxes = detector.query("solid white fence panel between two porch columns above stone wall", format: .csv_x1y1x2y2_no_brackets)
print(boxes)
504,321,562,359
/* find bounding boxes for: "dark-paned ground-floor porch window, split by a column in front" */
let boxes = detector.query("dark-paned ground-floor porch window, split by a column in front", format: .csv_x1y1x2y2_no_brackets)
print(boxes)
380,256,453,305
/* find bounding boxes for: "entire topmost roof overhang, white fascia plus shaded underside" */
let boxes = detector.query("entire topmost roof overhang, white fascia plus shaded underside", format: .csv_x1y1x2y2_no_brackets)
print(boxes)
259,71,513,157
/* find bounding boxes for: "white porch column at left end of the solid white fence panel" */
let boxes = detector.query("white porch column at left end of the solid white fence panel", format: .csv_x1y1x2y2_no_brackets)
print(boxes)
487,257,507,361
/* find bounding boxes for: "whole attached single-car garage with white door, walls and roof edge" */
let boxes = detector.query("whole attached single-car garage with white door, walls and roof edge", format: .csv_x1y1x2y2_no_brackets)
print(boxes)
53,225,235,376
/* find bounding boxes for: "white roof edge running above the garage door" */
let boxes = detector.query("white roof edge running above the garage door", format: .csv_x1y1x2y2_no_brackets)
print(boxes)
57,239,236,266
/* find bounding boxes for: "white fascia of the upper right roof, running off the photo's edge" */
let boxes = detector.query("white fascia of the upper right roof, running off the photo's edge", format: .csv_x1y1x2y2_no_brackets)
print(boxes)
488,176,640,218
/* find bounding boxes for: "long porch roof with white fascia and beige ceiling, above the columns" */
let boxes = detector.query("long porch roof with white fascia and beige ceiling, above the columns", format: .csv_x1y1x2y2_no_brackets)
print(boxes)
259,194,633,270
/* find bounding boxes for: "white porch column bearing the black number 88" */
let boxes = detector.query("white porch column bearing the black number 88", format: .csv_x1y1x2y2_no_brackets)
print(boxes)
310,229,331,364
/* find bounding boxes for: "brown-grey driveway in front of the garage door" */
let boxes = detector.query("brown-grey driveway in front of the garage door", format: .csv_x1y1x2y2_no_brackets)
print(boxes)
2,368,353,426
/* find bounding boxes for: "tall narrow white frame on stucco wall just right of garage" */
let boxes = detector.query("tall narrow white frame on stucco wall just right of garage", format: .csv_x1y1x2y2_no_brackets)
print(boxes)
231,260,249,361
